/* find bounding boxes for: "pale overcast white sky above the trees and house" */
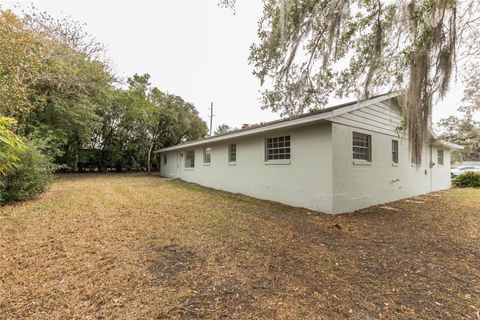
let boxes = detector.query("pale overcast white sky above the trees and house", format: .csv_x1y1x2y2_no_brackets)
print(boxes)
1,0,463,129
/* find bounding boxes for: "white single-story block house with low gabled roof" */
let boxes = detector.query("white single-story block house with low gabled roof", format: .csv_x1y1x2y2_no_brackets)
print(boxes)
156,93,461,213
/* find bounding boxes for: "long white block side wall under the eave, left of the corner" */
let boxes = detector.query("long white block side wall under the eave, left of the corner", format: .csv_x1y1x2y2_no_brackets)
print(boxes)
161,122,332,212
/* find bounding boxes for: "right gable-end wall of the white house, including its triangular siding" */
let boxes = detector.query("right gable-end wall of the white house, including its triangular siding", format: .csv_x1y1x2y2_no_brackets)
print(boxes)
332,100,450,213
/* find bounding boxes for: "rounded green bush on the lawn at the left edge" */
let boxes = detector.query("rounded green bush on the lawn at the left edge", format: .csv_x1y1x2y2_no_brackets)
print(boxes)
0,142,54,204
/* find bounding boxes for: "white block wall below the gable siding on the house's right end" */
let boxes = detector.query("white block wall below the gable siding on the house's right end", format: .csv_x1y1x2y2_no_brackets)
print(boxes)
332,123,450,213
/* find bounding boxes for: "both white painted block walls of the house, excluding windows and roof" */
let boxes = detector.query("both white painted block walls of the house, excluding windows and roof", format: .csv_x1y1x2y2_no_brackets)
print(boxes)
161,102,450,213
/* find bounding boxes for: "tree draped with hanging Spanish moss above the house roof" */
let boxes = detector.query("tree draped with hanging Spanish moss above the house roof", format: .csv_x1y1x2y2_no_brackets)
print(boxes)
221,0,480,163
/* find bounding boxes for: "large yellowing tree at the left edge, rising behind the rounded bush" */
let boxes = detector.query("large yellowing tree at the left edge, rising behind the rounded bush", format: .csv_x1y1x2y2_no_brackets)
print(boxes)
0,9,113,169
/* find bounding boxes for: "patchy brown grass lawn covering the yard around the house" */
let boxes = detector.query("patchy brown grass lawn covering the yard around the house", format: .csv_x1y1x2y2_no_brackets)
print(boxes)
0,174,480,320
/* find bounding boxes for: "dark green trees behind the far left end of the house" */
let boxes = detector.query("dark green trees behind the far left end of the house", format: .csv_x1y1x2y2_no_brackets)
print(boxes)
90,74,207,171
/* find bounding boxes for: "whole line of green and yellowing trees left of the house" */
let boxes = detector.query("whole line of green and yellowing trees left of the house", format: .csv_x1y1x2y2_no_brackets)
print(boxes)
0,8,206,179
